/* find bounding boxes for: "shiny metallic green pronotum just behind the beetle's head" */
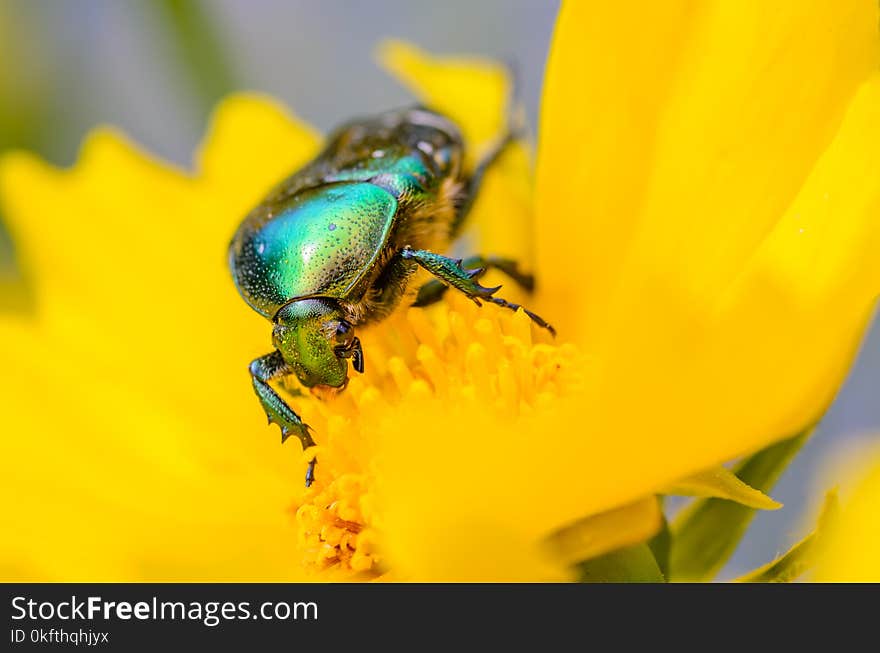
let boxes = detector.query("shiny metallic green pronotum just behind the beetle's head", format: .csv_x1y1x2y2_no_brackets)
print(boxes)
229,182,397,318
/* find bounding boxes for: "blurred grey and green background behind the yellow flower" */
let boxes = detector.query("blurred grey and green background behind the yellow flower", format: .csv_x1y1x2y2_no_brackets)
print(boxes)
0,0,880,578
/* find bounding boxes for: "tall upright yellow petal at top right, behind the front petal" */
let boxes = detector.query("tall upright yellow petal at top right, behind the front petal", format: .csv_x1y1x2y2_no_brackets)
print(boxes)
538,0,880,342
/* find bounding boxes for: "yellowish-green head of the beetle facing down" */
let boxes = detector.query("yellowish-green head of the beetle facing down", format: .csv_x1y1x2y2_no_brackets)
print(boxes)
272,299,364,388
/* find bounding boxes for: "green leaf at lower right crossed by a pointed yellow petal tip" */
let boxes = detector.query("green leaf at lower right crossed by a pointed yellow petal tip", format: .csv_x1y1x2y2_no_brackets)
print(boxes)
669,429,812,581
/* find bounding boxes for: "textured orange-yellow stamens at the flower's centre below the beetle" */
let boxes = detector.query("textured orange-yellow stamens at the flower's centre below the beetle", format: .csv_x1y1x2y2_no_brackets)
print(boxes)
291,292,582,580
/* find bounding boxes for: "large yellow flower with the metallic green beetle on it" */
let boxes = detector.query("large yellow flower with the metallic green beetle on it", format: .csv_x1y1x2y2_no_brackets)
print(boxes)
0,0,880,580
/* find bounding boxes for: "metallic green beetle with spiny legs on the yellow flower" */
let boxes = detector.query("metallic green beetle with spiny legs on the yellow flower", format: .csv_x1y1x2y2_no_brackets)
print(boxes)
229,106,555,486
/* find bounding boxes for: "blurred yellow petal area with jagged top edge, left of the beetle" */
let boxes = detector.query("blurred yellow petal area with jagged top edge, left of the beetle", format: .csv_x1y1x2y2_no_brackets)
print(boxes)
0,98,324,580
